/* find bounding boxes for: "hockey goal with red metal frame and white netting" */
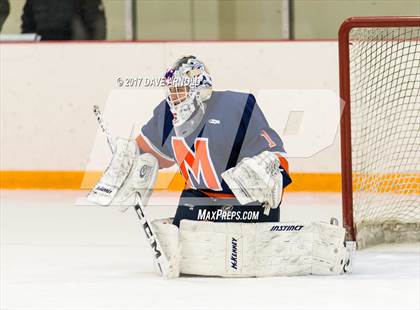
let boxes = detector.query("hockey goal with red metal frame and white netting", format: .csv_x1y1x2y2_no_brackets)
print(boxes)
339,17,420,247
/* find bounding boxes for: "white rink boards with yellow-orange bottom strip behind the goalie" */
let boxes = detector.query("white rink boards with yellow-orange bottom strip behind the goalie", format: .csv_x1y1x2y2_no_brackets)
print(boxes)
0,41,340,191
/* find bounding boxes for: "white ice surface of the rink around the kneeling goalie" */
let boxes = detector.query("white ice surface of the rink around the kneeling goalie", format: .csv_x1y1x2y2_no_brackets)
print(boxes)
0,191,420,310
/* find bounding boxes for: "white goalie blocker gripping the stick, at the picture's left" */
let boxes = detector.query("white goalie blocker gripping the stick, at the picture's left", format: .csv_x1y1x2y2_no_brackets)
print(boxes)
87,138,159,208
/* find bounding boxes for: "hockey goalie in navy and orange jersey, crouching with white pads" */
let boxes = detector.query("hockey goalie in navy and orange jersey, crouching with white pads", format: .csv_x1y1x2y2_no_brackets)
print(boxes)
88,56,353,277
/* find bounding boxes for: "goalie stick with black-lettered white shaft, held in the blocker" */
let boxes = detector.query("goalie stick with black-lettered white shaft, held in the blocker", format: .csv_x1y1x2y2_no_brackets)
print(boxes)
93,105,171,278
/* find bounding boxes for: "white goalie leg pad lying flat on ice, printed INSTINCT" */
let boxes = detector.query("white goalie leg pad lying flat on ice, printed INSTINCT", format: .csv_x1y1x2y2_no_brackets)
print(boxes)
179,220,347,277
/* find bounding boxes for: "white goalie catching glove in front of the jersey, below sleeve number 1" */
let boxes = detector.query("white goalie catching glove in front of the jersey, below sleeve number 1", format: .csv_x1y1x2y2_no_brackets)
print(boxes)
222,151,283,214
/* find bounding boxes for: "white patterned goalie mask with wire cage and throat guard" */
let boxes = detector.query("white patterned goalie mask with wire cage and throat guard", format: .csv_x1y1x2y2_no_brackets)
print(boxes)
165,56,212,137
